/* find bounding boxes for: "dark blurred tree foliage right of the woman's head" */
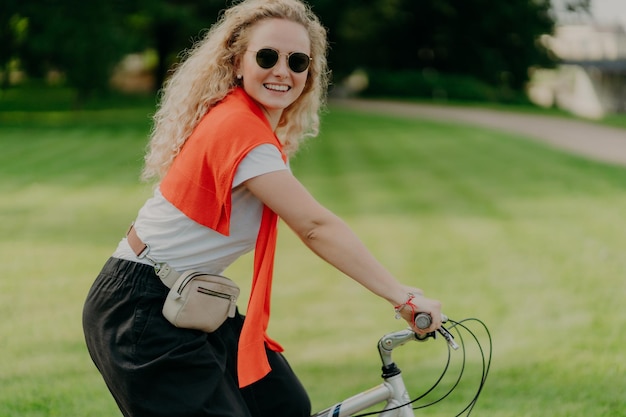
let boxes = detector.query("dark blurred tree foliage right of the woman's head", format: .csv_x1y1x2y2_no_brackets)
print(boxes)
312,0,554,89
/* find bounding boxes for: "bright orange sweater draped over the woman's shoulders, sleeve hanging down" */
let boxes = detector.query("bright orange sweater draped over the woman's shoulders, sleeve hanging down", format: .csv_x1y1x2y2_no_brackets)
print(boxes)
160,87,287,387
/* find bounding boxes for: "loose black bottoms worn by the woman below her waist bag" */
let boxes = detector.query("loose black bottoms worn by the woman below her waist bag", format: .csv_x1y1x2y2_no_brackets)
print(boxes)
83,258,311,417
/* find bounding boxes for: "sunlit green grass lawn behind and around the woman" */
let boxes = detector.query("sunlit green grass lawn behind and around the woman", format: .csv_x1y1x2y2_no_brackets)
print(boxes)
0,92,626,417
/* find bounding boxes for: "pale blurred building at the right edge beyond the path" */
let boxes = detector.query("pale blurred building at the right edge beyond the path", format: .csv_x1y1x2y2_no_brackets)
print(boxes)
528,24,626,118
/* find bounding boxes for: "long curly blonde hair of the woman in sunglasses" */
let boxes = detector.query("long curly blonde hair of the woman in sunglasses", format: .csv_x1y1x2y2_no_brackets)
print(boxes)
141,0,329,181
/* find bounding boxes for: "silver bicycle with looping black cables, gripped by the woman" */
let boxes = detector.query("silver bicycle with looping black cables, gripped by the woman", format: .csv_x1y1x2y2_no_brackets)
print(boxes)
311,313,492,417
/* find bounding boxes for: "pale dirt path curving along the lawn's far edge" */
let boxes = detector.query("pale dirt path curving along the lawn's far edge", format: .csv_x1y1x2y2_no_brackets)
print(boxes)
332,99,626,166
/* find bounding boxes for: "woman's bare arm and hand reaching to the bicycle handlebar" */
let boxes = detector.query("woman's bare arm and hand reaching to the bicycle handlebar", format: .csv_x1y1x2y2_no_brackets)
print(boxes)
245,167,441,333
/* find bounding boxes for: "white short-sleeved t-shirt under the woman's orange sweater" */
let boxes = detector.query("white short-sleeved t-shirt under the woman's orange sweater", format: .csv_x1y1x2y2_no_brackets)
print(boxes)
113,144,289,274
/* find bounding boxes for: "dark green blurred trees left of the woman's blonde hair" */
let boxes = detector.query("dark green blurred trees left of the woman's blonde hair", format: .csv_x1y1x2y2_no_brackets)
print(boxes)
8,0,226,98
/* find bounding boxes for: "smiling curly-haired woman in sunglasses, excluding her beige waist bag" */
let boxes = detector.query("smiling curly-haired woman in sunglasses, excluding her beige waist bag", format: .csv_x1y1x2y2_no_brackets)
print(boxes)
83,0,441,417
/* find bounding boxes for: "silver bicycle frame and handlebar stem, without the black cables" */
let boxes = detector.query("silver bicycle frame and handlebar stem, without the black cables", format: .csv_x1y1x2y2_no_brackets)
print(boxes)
311,329,426,417
